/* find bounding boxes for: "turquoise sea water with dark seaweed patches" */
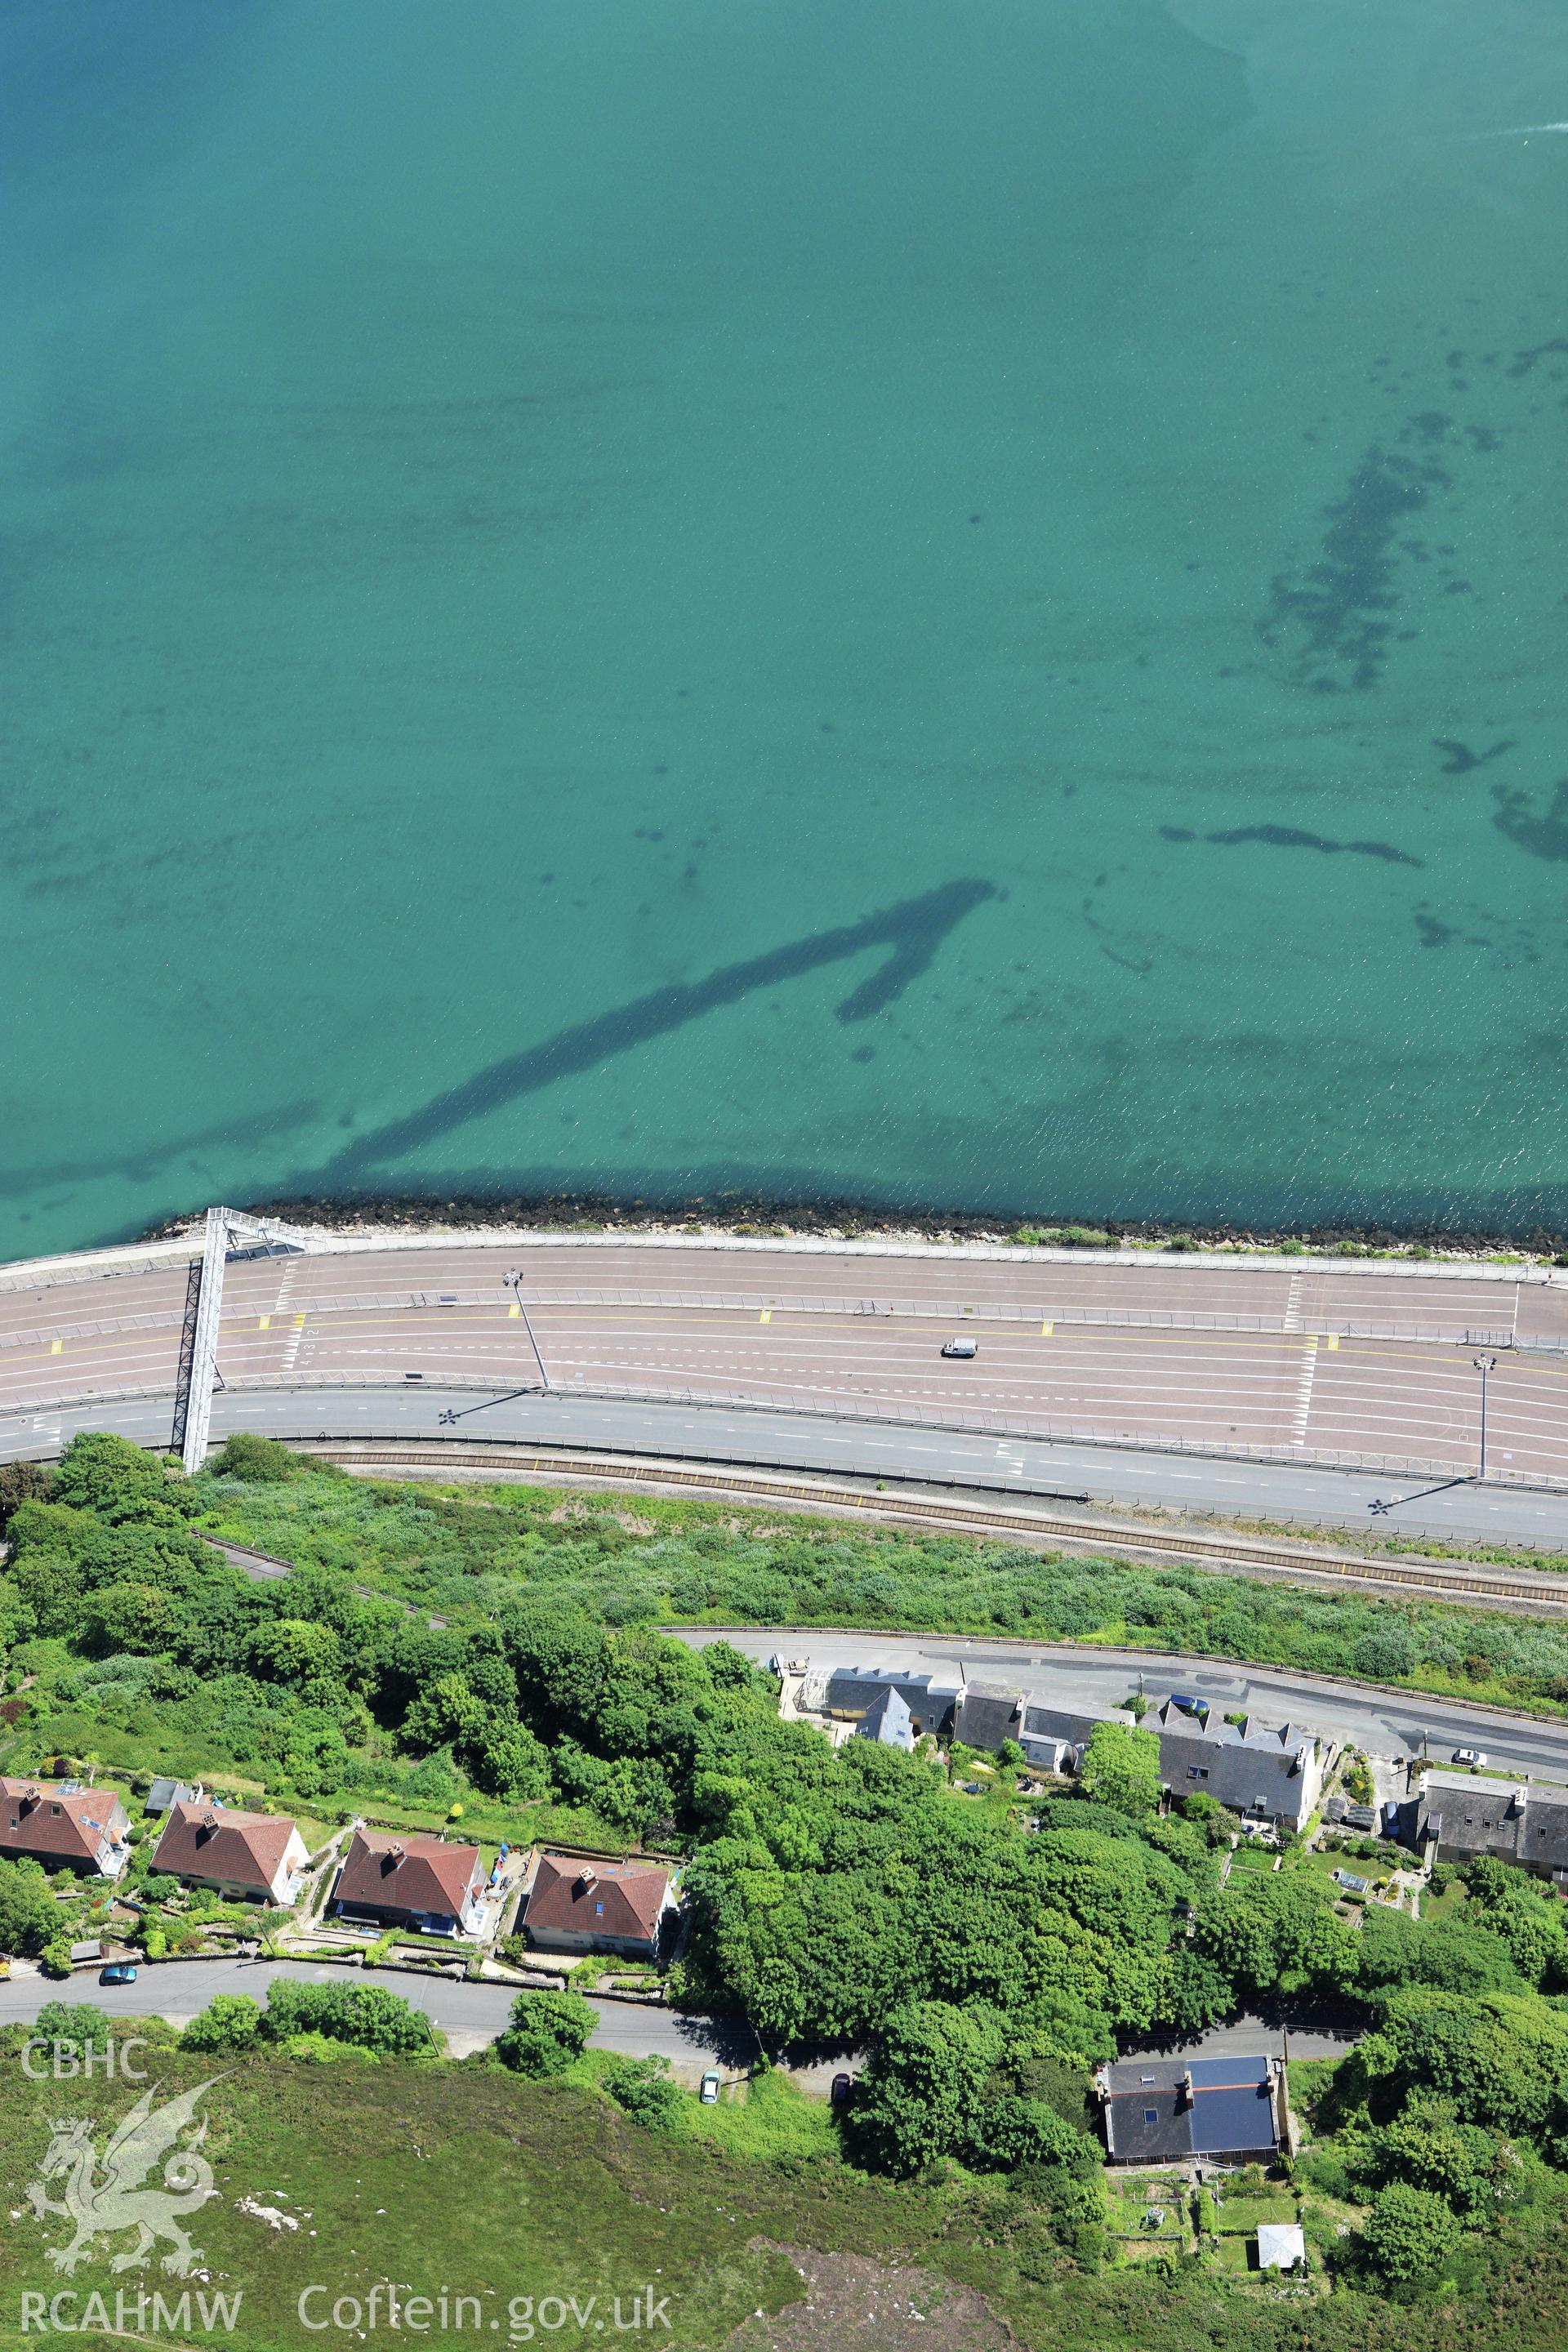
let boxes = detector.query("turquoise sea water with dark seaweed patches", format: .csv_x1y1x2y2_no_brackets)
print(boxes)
0,0,1568,1254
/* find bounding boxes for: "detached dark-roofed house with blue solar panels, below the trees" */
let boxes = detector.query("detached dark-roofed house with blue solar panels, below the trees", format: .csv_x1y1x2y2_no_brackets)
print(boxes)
1095,2056,1290,2164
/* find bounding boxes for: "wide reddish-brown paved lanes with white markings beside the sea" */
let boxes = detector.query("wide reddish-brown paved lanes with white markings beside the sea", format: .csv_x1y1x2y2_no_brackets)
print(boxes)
0,1237,1568,1480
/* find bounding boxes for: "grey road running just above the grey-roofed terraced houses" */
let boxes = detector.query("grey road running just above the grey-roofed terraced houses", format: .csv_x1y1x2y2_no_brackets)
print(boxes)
677,1628,1568,1783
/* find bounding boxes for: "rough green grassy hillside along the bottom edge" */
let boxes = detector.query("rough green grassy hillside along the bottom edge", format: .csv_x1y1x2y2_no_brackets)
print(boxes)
0,2028,1561,2352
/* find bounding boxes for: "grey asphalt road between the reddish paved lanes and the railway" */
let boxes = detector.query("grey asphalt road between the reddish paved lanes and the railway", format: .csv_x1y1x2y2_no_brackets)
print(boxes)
0,1381,1568,1548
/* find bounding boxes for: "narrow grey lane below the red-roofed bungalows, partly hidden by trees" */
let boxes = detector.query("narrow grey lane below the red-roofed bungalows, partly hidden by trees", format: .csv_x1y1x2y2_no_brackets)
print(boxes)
0,1959,1356,2091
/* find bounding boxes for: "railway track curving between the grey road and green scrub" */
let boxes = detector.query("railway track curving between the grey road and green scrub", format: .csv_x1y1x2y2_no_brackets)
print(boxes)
296,1440,1568,1616
